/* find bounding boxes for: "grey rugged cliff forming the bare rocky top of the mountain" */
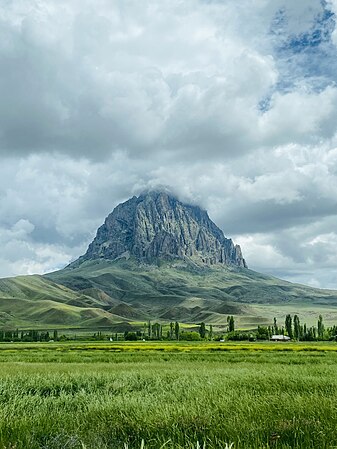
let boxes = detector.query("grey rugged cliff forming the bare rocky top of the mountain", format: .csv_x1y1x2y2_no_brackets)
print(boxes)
80,192,247,268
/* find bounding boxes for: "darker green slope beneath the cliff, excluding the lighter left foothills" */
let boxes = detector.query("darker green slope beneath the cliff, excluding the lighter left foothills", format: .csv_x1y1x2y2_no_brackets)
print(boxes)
48,259,337,324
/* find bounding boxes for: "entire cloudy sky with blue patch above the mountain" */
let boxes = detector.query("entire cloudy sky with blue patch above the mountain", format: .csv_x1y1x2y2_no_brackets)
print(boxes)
0,0,337,288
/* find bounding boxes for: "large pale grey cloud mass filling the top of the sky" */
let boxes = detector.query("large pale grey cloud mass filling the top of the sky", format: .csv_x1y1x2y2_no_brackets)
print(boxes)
0,0,318,159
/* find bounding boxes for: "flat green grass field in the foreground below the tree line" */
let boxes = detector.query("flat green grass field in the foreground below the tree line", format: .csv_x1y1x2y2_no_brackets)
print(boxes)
0,342,337,449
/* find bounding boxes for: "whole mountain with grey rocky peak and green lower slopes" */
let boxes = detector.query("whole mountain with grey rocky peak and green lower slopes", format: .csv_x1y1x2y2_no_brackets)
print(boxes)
0,192,337,331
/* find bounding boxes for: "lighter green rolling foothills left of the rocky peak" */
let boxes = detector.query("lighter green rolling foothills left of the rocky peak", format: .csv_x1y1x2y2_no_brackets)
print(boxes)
0,275,130,329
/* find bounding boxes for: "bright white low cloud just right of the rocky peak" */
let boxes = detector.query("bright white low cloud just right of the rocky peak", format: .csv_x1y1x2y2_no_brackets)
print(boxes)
236,217,337,289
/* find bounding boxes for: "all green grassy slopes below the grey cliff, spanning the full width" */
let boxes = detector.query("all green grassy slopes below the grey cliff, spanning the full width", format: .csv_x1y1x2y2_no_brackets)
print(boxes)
0,259,337,332
